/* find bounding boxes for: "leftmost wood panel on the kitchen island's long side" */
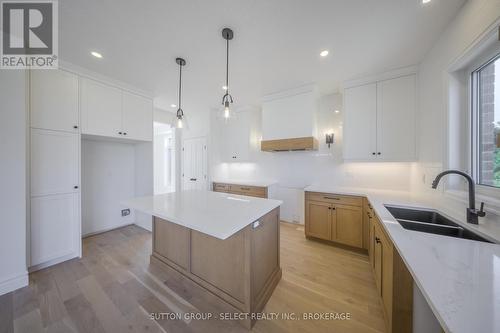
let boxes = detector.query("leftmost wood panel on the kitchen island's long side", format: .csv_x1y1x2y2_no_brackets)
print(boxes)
153,217,190,271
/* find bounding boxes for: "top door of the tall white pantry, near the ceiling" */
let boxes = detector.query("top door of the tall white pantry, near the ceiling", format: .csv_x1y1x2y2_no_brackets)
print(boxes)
30,70,80,133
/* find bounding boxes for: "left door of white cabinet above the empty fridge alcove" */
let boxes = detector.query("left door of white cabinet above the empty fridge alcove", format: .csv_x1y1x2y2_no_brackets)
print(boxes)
81,79,123,138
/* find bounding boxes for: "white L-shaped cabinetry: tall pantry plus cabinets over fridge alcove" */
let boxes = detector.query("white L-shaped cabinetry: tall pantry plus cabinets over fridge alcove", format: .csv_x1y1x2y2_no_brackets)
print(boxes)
28,70,153,270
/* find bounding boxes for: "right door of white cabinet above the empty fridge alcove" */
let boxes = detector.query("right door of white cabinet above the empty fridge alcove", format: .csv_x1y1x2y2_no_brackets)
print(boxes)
122,91,153,141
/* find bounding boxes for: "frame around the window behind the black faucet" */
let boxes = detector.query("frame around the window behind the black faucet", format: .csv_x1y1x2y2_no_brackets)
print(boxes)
466,46,500,192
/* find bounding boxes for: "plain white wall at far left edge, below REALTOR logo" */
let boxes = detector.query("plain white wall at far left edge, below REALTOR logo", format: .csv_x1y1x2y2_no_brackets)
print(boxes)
0,70,28,295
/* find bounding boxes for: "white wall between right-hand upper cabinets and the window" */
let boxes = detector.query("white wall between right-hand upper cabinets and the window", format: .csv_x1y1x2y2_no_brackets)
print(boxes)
411,0,500,201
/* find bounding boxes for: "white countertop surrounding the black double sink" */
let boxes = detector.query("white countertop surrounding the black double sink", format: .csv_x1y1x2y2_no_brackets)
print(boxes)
304,185,500,333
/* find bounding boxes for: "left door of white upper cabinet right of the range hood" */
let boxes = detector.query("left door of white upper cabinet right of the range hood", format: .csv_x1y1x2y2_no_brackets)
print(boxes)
343,83,377,160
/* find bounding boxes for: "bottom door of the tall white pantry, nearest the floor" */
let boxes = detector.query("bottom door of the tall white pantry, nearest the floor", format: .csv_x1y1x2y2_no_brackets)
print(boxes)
30,193,81,266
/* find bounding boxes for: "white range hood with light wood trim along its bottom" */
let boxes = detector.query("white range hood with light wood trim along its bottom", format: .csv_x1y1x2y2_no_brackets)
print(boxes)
260,85,318,152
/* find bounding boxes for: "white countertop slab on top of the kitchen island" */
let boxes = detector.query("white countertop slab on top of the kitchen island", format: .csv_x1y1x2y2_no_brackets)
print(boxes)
123,190,282,239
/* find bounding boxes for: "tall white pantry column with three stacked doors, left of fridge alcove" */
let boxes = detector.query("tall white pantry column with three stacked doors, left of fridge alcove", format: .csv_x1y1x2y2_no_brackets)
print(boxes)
29,70,81,268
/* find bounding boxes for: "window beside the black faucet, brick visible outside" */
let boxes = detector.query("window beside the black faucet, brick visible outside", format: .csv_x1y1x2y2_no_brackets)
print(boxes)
471,54,500,187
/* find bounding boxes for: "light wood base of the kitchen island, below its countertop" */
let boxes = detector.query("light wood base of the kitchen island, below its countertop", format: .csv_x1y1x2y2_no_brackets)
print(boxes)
151,208,281,328
